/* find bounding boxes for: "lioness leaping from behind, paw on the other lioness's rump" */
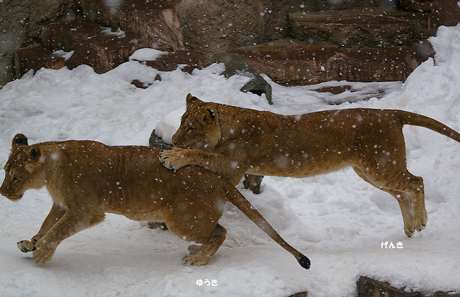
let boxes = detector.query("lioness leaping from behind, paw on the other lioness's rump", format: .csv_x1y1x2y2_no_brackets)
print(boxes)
160,94,460,237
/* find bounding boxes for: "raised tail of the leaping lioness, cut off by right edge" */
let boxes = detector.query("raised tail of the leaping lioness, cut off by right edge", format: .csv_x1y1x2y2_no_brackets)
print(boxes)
395,110,460,142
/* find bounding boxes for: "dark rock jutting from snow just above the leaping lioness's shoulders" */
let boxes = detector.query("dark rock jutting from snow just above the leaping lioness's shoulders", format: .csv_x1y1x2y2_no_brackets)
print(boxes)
212,53,273,104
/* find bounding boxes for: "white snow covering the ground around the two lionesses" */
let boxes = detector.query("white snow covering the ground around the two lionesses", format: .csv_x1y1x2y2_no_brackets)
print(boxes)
0,26,460,297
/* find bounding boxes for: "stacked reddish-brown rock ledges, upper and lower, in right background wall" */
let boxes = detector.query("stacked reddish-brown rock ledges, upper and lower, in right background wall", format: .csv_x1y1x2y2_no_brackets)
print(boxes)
231,8,433,85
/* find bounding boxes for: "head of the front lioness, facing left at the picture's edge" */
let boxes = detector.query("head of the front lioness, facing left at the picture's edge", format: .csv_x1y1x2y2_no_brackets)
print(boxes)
0,134,44,200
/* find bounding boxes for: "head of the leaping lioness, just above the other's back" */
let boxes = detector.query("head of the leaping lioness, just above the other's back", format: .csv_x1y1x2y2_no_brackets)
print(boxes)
172,94,222,150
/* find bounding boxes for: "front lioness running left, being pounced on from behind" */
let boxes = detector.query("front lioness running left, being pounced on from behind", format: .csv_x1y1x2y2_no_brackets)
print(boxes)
0,134,310,269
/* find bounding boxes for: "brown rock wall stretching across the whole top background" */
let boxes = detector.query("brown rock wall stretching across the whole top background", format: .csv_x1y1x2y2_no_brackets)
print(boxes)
0,0,460,85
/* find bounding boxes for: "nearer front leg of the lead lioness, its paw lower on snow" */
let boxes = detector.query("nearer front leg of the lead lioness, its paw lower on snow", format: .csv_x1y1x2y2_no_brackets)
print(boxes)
34,207,104,264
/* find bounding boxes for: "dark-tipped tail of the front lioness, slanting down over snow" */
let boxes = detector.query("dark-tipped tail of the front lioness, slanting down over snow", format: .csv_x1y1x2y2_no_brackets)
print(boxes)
226,183,310,269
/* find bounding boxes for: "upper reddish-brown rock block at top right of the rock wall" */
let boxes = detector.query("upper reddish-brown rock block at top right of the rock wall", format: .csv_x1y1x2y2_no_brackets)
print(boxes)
289,8,428,48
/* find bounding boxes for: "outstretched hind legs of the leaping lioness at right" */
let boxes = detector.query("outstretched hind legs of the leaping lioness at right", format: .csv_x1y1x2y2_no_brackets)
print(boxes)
354,167,428,237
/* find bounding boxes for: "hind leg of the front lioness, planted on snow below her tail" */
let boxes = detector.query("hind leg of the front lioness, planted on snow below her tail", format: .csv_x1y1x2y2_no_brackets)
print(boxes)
182,224,227,266
